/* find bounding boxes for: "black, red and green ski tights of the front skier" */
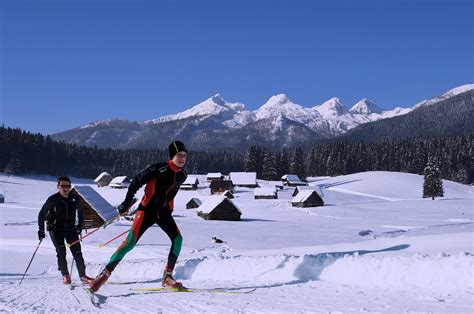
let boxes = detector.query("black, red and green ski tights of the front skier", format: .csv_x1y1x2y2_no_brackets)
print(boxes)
105,210,183,272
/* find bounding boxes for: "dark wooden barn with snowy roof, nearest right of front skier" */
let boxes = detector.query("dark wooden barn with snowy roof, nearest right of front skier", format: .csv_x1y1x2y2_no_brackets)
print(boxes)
197,195,242,221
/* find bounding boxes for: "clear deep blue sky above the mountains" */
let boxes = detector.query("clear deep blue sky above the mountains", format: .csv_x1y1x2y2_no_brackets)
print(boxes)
0,0,474,134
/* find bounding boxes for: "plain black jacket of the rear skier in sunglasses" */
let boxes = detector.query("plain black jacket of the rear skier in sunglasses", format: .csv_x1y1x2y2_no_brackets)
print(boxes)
38,192,83,231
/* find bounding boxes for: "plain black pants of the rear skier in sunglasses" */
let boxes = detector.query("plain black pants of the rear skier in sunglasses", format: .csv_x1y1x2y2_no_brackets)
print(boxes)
49,228,86,277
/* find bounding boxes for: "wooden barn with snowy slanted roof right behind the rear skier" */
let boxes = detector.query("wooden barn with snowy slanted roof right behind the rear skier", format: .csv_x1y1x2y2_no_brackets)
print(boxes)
71,185,118,229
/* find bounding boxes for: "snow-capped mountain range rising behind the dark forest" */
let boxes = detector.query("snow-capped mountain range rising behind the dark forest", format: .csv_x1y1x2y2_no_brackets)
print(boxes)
53,84,474,150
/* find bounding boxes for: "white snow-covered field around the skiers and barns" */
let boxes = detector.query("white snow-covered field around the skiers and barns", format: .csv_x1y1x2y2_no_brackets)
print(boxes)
0,172,474,313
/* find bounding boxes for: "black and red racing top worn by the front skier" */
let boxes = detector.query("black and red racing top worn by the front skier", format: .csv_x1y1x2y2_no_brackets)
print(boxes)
125,161,187,211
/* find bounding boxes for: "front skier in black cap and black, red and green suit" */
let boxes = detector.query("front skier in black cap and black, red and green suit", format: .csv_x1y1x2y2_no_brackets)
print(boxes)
89,141,188,292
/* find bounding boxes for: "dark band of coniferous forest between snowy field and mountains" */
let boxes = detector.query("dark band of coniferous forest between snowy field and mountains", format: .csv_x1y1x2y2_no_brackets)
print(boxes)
0,127,474,184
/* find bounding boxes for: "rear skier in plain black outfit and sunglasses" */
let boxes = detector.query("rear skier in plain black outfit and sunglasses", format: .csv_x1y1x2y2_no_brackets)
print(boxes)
38,177,92,285
